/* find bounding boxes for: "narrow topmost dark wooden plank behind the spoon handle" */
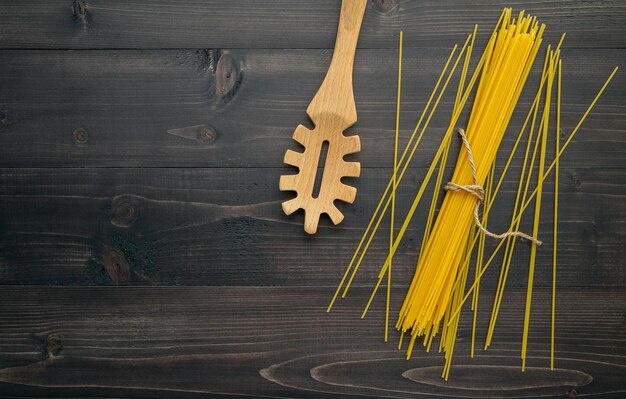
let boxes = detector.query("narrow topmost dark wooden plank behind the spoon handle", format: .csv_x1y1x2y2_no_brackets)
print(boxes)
0,0,626,49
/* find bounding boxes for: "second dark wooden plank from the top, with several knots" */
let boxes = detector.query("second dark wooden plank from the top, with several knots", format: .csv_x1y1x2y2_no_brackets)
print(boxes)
0,48,626,167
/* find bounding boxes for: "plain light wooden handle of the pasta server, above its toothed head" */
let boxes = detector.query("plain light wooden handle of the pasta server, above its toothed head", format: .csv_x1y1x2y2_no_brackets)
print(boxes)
307,0,367,130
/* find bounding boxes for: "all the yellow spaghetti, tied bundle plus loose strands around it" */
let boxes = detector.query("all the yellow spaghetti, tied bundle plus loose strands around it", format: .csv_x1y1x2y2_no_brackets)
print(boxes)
327,8,617,380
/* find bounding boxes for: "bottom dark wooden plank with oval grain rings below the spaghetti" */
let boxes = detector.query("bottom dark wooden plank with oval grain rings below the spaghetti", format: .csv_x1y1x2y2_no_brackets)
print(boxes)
0,286,626,398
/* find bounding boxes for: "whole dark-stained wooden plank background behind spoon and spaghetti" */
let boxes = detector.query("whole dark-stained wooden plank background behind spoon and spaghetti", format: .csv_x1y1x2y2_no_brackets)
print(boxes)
0,0,626,398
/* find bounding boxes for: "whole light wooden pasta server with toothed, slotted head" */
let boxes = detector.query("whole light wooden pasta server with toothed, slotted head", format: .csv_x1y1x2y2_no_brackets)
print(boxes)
279,0,367,234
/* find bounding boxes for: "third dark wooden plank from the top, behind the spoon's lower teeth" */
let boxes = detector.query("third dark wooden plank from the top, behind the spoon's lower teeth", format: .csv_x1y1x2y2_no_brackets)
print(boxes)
0,166,626,286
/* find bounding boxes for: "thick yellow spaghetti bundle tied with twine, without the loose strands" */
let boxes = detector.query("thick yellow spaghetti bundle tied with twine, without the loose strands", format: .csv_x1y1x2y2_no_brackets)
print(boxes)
396,9,545,355
